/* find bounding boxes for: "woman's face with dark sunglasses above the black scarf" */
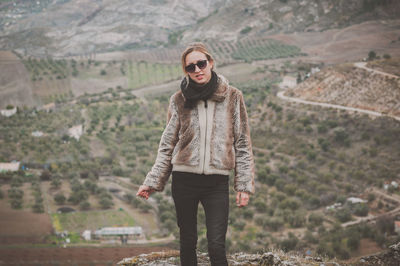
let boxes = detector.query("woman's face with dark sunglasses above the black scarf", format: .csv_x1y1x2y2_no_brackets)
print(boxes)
185,51,213,84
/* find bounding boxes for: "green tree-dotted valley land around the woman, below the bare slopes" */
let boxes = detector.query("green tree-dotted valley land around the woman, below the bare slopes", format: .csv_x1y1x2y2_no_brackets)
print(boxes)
0,55,400,260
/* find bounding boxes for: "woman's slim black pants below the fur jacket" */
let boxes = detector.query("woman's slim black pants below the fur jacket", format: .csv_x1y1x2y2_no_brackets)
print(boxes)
172,172,229,266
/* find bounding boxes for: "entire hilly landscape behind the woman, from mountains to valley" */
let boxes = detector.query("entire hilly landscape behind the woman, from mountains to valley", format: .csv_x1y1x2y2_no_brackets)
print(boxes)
0,0,400,265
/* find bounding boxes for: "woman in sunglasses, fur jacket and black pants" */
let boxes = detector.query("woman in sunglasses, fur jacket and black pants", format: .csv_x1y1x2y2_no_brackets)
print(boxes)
136,43,254,266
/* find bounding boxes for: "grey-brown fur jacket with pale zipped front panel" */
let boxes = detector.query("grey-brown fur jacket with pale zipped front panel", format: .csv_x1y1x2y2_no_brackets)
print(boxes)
143,75,254,193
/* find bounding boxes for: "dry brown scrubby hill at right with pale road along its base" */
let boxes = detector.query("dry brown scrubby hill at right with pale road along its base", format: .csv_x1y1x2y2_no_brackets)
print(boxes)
285,58,400,117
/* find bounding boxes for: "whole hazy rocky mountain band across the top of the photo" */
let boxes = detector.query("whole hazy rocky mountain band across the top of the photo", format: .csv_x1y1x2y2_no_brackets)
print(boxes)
0,0,400,56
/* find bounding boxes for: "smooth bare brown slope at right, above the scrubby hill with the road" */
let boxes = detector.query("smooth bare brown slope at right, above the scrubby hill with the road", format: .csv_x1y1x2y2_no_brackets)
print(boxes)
269,20,400,64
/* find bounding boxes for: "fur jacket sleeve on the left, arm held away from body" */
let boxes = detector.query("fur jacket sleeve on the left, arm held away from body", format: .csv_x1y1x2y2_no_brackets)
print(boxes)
143,95,180,191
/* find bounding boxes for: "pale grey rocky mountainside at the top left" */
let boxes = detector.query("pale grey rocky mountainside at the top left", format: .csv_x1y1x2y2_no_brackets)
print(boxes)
0,0,227,55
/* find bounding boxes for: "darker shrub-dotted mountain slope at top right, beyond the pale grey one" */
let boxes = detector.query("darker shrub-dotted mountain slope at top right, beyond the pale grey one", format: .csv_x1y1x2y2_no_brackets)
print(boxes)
188,0,400,42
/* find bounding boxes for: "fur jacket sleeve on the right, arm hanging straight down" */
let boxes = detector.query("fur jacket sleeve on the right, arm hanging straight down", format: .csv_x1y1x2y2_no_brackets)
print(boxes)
234,91,255,193
